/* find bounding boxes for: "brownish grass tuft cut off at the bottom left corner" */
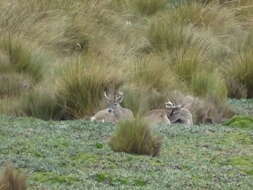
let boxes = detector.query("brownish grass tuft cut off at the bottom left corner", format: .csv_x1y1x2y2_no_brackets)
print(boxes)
0,165,27,190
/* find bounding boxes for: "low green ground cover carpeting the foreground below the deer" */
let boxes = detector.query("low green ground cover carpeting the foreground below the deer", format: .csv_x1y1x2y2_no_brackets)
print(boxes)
0,113,253,190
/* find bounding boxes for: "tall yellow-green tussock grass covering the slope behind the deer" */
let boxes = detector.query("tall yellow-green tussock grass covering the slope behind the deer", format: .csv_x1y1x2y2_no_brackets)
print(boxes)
0,0,253,120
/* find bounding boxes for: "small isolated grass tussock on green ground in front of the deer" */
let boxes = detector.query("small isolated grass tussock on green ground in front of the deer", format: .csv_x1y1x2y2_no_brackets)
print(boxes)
109,119,162,156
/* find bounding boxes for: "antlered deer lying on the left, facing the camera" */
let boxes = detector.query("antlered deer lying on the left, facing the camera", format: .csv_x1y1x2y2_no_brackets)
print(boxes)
90,91,134,124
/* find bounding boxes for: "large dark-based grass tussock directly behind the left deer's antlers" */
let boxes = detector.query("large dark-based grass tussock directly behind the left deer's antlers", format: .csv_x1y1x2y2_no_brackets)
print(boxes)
56,58,122,118
